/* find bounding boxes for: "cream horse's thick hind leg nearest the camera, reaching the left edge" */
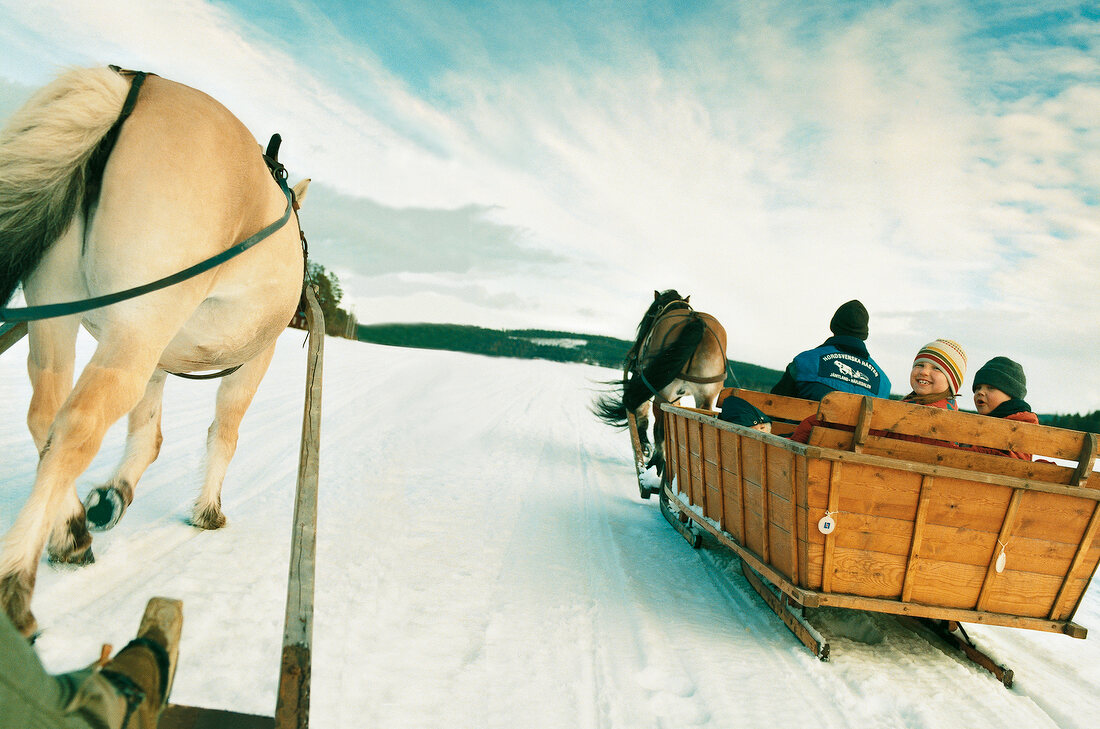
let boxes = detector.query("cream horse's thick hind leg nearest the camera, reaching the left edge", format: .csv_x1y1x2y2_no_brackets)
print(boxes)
0,345,157,636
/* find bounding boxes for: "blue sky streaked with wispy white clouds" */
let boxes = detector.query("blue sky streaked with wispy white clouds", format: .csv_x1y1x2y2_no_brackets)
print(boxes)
0,0,1100,411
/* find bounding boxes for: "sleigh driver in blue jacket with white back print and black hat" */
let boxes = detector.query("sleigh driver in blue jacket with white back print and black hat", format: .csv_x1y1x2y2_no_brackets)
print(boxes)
771,299,890,400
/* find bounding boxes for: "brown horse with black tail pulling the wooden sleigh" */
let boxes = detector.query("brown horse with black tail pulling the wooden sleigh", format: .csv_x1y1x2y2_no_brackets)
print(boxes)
593,289,726,474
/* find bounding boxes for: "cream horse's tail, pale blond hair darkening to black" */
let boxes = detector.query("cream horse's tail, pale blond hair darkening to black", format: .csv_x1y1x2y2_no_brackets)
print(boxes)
0,68,130,306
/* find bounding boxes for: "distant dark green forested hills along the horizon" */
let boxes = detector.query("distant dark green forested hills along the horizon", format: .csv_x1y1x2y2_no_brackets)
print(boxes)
358,324,1100,433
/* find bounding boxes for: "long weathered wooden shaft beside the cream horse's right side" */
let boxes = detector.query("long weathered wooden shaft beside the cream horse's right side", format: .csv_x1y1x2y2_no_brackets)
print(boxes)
275,286,325,729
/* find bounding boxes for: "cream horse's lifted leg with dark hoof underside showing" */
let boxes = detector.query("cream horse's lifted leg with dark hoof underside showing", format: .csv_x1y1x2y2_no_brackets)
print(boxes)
80,369,167,536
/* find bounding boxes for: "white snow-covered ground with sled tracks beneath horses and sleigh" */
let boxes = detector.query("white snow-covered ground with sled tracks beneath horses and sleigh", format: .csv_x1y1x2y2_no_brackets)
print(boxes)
0,331,1100,729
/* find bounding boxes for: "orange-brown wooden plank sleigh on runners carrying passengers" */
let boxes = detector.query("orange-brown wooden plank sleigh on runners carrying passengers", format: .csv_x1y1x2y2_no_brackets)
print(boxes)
629,390,1100,686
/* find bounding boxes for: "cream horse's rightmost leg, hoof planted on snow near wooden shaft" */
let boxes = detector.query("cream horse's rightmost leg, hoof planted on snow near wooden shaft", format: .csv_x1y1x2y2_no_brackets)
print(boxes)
191,342,275,529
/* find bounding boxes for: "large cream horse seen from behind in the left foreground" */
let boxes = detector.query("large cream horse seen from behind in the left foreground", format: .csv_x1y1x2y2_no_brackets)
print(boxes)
0,68,308,634
